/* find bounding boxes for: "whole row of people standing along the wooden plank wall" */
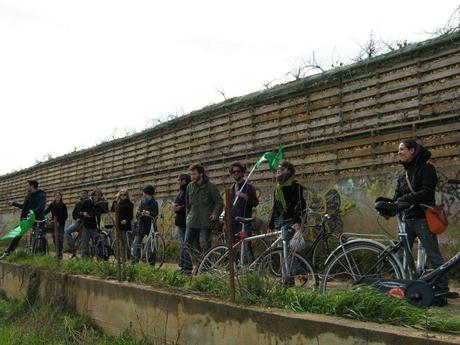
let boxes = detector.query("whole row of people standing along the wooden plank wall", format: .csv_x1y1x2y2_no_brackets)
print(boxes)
0,140,449,305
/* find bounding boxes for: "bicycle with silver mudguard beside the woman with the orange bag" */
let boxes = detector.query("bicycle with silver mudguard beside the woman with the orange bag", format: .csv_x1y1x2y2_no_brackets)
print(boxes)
320,180,460,307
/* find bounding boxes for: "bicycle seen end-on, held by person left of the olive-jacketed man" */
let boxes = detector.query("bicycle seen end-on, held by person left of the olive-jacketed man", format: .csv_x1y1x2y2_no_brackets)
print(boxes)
127,214,166,268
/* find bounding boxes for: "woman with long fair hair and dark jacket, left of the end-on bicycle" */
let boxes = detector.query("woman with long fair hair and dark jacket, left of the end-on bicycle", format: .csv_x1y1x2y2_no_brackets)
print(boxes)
111,189,134,262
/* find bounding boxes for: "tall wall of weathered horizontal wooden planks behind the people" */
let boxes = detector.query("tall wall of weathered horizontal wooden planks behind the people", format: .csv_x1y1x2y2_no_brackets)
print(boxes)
0,35,460,213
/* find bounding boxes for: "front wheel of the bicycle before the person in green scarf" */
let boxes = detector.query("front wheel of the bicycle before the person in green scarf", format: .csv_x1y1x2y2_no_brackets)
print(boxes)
257,248,317,290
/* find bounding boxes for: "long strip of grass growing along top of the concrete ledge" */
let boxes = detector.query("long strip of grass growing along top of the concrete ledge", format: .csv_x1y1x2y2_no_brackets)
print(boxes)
3,253,460,334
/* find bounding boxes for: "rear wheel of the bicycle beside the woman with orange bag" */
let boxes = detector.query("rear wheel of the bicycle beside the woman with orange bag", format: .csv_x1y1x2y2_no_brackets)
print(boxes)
320,243,403,292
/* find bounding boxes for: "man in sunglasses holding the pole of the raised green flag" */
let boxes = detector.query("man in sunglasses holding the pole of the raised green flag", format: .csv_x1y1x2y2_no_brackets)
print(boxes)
228,162,259,262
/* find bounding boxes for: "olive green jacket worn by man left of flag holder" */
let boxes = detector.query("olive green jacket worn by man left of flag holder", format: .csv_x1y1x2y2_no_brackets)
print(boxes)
185,176,224,229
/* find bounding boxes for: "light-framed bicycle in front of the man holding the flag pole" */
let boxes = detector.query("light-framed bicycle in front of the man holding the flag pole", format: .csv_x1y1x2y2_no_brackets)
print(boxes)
195,217,317,289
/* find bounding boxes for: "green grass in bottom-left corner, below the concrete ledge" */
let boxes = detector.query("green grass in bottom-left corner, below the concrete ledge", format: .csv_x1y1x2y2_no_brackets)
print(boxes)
0,288,147,345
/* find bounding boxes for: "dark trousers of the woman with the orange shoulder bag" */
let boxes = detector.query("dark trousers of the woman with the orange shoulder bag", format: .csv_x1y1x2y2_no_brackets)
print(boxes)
405,218,449,293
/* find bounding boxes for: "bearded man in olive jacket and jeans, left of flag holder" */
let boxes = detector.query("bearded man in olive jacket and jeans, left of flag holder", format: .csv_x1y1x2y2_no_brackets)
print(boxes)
182,164,224,271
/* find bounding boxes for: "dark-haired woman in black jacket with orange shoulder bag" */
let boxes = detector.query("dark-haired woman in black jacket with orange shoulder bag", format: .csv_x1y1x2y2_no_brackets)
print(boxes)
393,140,449,306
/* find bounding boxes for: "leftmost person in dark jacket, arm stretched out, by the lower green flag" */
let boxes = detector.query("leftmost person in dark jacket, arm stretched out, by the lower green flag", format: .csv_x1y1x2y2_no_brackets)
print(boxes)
0,180,46,260
